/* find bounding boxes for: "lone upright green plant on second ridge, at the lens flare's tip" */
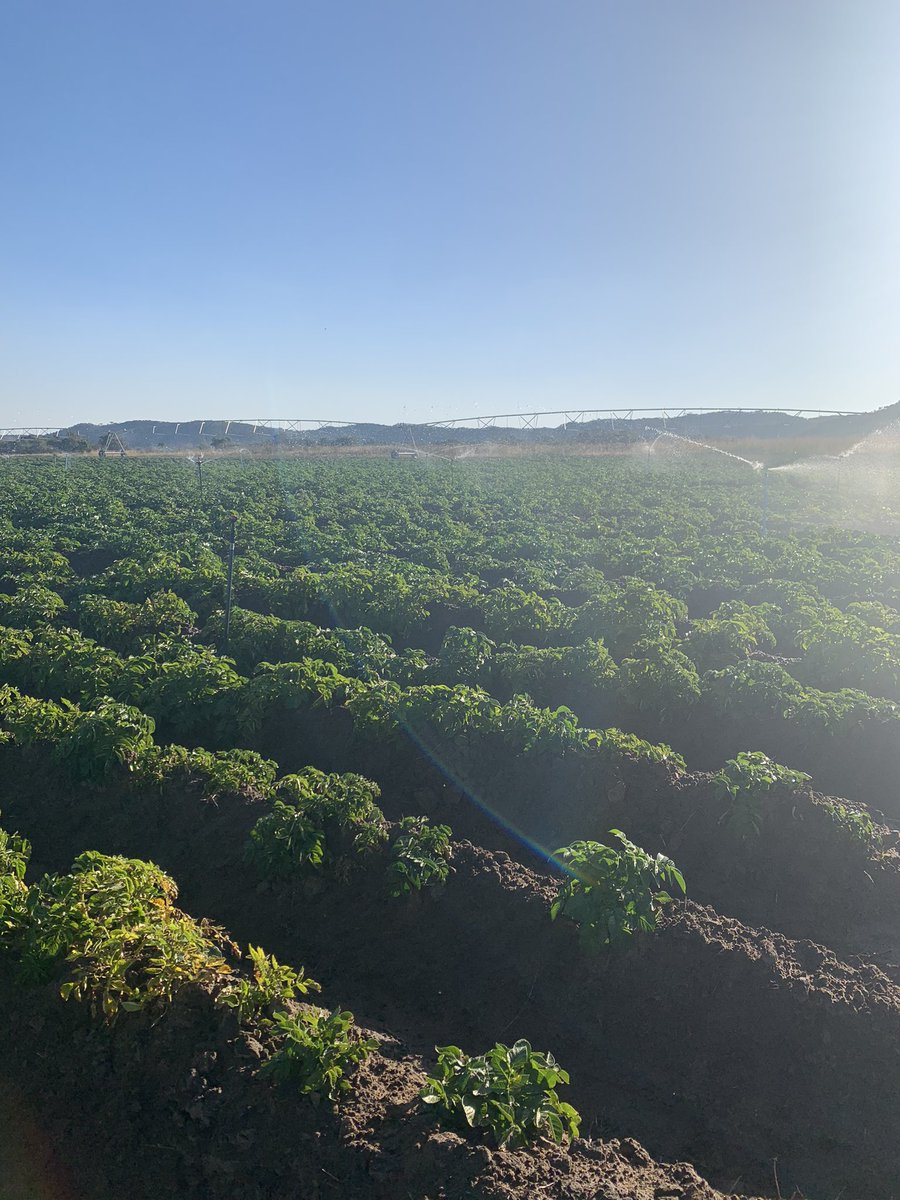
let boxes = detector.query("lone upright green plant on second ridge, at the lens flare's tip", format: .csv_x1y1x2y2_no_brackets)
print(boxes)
550,829,685,946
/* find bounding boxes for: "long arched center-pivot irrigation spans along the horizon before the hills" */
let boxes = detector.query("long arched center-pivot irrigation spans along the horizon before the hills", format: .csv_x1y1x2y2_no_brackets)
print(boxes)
0,406,858,443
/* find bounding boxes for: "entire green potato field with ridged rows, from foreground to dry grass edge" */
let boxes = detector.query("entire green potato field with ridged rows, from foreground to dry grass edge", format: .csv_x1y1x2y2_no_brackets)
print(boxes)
0,444,900,1200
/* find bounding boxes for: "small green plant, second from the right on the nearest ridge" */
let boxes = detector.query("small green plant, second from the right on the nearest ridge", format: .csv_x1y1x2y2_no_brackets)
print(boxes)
259,1006,378,1100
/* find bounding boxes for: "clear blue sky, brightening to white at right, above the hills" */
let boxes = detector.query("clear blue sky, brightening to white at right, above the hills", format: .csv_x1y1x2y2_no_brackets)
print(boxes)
0,0,900,425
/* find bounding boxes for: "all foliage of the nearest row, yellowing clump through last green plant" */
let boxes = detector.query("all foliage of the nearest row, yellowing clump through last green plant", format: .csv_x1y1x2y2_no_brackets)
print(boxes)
0,828,580,1148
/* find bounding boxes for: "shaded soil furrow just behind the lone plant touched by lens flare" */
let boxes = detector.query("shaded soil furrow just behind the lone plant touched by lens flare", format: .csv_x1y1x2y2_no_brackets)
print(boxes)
232,710,900,958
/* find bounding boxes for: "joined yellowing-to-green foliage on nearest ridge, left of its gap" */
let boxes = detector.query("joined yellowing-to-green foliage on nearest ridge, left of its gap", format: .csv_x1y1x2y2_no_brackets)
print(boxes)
0,829,378,1100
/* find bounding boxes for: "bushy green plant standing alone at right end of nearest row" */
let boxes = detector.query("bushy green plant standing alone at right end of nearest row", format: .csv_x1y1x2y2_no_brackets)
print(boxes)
419,1039,581,1150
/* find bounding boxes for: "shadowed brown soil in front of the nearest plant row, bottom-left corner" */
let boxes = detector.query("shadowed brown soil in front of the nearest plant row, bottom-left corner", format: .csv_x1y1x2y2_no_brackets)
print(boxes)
0,977,763,1200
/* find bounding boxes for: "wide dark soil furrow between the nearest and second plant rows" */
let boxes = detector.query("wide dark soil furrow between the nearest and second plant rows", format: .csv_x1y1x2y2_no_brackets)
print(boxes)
4,760,900,1200
